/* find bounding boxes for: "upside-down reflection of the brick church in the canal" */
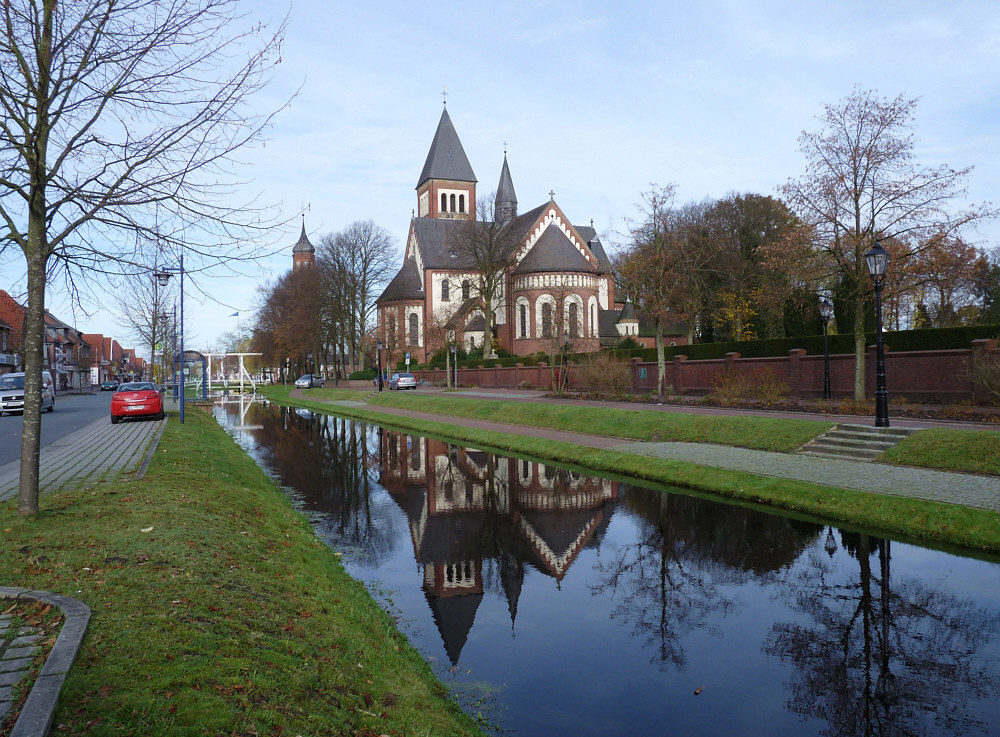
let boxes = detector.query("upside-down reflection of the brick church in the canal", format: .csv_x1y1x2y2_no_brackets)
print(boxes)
379,429,618,665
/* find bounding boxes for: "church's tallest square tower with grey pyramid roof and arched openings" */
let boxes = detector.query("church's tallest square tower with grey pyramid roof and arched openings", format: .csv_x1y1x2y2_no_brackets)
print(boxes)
417,107,476,220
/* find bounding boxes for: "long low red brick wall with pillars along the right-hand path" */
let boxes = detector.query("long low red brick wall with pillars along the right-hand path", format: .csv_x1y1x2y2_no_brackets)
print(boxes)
413,339,997,404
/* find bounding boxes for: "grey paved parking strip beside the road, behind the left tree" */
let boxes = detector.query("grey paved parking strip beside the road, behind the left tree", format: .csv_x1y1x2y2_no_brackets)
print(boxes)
0,417,166,502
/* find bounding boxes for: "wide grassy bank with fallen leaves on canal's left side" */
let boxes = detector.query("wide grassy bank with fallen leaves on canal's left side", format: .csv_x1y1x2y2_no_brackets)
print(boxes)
0,411,477,735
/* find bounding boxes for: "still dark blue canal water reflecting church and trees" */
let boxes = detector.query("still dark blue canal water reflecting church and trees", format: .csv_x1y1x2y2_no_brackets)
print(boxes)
216,402,1000,737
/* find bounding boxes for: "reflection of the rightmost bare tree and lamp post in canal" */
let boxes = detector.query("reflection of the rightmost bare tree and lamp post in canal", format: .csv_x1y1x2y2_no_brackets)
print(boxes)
764,533,1000,737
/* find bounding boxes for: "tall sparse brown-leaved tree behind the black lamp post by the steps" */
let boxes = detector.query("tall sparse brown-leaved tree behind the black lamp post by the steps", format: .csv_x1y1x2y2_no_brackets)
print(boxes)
781,88,992,401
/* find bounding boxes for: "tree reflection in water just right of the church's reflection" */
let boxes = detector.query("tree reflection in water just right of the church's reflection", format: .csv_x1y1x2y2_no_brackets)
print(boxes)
592,489,821,668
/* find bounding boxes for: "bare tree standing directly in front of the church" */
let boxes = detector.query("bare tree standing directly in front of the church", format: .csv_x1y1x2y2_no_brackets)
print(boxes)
448,195,521,358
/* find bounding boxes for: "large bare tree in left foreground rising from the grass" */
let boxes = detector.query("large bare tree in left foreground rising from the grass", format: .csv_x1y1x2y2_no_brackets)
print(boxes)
0,0,283,515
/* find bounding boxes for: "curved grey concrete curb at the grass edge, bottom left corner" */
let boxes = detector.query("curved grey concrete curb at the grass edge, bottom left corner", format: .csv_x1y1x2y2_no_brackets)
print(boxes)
0,586,90,737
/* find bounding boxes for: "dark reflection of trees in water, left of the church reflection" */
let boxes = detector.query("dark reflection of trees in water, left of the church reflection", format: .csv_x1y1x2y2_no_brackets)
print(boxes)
236,407,394,564
